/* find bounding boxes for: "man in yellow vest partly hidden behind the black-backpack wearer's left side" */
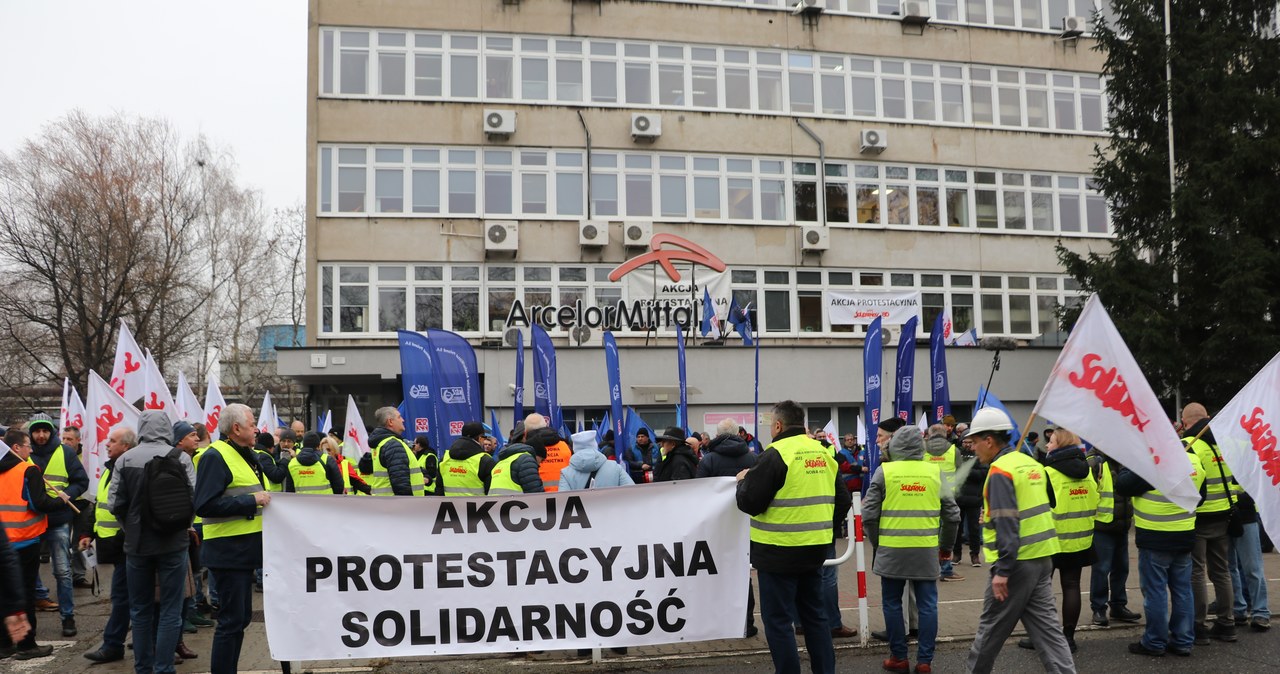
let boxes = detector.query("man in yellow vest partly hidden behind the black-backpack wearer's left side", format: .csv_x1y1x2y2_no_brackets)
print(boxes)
79,426,138,662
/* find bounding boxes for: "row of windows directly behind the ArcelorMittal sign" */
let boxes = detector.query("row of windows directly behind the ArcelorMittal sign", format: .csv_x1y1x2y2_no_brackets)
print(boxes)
319,263,1083,344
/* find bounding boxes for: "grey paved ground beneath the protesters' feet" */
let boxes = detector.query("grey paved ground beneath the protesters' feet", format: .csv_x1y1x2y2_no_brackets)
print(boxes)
15,542,1280,674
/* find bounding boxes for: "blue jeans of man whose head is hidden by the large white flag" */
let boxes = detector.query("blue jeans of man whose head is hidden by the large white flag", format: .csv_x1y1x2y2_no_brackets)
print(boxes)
1138,547,1196,652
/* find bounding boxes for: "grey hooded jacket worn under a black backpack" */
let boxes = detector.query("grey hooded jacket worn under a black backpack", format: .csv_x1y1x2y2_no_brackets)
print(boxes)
106,409,196,555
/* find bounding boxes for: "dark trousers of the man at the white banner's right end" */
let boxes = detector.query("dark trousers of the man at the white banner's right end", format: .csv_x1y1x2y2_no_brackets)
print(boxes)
752,569,836,674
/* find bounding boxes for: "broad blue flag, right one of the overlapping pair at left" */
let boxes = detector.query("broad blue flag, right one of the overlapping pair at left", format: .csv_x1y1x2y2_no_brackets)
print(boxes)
426,327,484,450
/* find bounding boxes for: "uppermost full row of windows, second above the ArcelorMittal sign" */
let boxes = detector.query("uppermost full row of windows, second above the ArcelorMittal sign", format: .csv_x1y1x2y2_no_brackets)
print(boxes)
320,28,1106,133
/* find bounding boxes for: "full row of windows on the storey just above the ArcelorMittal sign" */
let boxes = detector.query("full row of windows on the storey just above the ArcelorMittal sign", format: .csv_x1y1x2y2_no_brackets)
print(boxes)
319,146,1110,234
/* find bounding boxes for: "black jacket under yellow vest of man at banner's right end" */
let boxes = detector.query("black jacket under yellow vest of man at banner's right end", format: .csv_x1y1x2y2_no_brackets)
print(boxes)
737,427,852,574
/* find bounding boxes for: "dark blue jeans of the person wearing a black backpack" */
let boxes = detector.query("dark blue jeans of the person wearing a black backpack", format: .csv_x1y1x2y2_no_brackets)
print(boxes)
125,547,187,674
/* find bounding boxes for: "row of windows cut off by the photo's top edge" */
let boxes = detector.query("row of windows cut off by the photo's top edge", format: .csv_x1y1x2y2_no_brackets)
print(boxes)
640,0,1115,32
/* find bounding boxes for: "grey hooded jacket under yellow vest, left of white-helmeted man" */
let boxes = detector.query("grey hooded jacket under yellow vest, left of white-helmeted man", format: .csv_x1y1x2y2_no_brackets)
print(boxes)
863,426,960,581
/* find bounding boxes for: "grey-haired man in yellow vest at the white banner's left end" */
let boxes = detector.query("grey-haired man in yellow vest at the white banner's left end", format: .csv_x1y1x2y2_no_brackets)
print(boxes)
196,403,271,674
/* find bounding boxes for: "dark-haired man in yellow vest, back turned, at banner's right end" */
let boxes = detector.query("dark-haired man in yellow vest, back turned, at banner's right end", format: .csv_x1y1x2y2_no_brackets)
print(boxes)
737,400,849,674
